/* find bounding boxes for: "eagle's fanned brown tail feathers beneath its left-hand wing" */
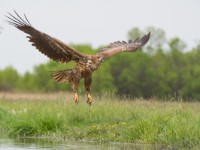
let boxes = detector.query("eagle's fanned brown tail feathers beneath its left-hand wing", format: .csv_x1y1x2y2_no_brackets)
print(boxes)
51,69,73,83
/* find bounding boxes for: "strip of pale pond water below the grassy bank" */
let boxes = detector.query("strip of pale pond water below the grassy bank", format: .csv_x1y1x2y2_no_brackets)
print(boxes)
0,138,161,150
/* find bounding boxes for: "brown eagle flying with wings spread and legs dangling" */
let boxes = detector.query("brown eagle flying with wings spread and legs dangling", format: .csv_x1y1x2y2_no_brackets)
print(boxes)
6,11,150,105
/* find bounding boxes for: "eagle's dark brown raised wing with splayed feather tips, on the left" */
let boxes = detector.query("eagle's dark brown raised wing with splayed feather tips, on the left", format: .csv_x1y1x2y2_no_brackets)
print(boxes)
6,11,85,63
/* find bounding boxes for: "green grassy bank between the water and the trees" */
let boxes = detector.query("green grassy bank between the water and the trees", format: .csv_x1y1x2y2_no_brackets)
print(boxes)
0,93,200,148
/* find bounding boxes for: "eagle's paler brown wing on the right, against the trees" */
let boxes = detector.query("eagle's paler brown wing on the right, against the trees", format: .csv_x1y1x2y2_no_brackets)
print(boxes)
98,32,151,59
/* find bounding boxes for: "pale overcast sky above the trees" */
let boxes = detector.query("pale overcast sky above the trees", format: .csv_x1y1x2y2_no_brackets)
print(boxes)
0,0,200,73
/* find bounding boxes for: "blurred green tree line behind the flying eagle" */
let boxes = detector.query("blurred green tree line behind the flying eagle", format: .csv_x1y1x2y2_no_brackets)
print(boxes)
0,27,200,100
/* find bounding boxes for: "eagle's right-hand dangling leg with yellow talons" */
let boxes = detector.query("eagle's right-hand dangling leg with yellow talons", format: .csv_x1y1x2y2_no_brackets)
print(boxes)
84,74,92,105
